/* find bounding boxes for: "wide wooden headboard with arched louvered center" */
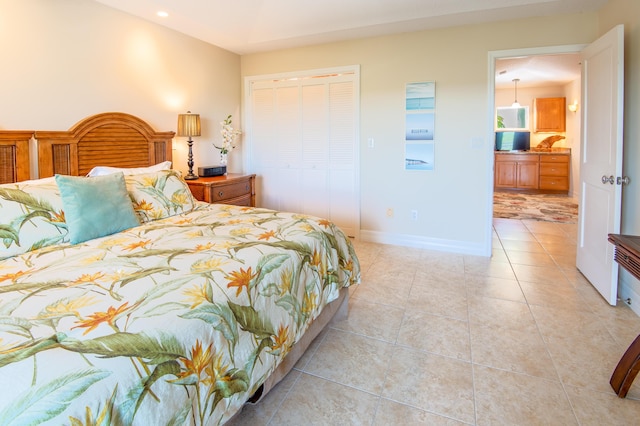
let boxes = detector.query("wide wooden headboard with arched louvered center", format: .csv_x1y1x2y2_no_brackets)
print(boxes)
35,112,175,178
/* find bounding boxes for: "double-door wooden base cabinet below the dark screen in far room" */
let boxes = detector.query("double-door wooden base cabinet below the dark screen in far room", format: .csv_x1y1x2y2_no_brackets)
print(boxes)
494,154,540,189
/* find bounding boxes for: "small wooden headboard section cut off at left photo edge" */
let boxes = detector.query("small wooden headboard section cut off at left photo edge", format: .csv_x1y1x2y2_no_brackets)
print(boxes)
0,130,34,183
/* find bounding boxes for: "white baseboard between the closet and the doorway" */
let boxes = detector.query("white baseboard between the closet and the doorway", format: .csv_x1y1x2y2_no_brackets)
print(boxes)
360,230,490,256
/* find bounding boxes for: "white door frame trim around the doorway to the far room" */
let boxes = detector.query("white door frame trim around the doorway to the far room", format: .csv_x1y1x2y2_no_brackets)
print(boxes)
485,44,588,250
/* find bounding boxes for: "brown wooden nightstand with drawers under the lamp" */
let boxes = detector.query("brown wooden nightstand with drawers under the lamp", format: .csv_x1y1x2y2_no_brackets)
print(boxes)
186,173,256,207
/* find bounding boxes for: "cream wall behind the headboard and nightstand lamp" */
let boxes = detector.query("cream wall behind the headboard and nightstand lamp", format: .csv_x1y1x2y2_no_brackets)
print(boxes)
0,0,240,175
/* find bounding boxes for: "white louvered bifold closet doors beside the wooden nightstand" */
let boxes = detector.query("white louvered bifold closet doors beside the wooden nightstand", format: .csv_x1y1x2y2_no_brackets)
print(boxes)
248,68,359,235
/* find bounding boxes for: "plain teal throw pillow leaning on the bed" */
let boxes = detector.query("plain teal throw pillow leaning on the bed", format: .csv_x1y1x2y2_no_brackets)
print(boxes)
55,172,140,244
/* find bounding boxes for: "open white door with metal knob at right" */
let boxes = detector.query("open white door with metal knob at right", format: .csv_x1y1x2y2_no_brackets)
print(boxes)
576,25,624,305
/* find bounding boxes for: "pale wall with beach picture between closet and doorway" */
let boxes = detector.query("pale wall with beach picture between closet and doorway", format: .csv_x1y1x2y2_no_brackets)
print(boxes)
241,13,597,254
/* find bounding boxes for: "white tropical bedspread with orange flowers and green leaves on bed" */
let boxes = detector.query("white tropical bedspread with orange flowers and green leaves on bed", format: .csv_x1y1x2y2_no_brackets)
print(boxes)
0,203,360,425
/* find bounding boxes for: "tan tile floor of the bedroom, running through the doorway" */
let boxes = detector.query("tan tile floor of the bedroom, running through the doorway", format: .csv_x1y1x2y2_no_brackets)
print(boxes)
230,219,640,425
